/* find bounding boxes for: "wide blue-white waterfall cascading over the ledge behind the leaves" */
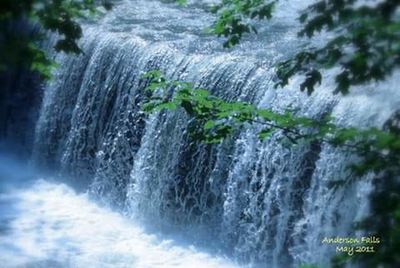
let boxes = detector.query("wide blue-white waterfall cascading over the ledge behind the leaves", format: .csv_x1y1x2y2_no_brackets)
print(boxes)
33,0,400,267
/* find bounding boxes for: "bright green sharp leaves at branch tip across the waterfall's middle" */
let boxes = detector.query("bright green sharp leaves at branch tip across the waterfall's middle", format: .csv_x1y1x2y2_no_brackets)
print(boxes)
143,71,315,143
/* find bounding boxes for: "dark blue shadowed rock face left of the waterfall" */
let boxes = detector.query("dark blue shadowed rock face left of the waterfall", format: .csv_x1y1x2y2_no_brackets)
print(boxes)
0,21,43,158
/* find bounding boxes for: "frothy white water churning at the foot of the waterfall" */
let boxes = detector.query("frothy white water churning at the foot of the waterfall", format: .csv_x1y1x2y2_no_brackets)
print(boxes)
0,176,237,268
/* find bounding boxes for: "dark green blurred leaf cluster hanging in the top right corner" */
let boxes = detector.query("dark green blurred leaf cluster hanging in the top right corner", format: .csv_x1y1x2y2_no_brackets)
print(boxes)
277,0,400,94
